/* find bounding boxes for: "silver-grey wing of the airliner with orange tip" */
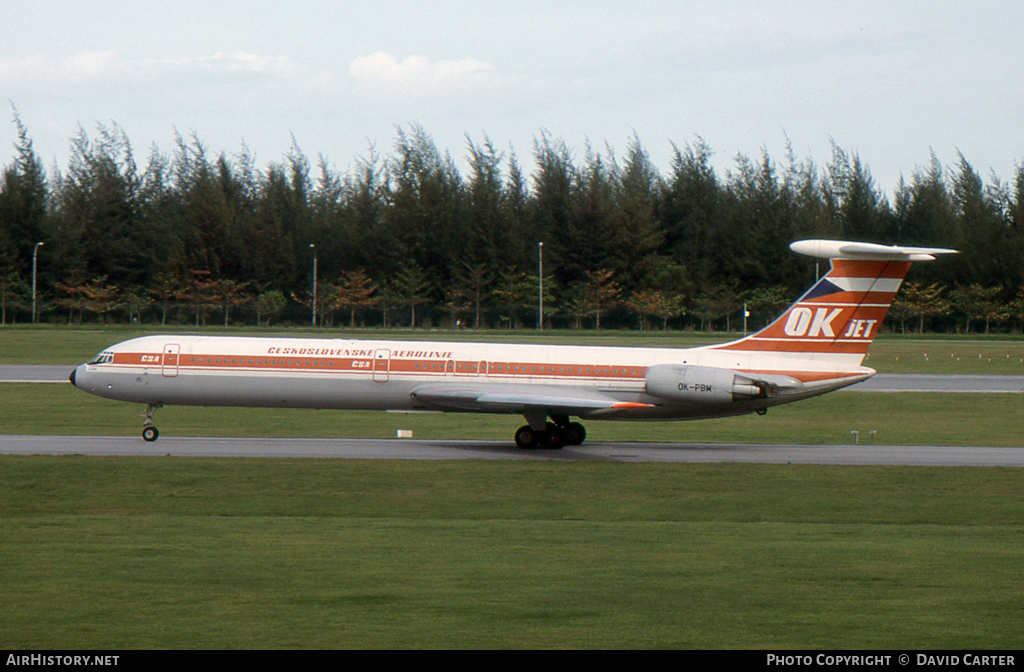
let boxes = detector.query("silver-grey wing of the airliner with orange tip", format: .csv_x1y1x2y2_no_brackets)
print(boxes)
411,383,650,417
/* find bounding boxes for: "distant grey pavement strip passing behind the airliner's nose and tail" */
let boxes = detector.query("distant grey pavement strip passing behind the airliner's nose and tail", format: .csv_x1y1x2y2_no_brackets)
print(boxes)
6,365,1024,394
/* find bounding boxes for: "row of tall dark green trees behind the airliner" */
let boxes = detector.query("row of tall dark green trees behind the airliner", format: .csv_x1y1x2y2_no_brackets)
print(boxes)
0,111,1024,331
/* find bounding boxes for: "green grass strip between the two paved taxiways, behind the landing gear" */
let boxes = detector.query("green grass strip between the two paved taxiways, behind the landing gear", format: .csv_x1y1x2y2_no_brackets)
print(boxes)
0,383,1024,446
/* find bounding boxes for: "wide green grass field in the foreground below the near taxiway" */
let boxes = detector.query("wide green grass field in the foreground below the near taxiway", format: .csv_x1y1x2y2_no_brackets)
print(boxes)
0,457,1024,648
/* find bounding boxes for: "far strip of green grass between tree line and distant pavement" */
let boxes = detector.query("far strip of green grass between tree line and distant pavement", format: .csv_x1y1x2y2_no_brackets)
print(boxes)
0,326,1024,375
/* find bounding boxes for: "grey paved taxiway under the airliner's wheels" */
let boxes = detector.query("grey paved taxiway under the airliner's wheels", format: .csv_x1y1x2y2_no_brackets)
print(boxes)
0,435,1024,467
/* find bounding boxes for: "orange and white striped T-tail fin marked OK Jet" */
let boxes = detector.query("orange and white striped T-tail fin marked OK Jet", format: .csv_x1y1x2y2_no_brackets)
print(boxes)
716,241,955,367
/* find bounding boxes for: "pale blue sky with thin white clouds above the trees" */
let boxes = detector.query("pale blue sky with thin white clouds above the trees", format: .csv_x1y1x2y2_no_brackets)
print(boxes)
0,0,1024,195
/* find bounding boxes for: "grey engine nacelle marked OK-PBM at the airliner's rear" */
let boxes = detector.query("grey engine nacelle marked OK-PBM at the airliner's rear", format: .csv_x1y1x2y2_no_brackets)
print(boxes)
646,364,774,404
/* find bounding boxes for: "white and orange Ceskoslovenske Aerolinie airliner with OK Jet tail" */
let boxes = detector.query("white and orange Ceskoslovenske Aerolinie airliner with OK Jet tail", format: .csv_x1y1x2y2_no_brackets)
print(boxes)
71,240,955,449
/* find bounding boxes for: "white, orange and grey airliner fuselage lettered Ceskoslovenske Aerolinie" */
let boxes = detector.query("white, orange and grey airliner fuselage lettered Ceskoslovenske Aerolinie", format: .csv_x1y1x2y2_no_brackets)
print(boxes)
68,335,873,419
